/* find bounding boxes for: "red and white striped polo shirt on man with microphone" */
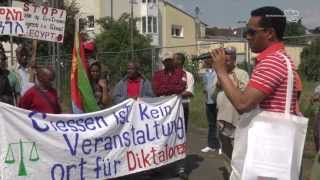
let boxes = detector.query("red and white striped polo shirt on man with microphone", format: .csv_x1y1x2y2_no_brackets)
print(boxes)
248,43,297,114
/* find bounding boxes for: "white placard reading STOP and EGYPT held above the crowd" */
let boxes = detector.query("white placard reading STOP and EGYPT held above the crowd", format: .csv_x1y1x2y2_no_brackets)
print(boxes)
12,1,66,43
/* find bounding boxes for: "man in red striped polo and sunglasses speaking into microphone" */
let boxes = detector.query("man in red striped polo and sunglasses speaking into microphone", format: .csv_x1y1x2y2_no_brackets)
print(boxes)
211,7,297,114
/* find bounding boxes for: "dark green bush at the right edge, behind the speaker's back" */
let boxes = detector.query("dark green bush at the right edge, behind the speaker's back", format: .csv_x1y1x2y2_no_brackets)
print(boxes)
299,38,320,81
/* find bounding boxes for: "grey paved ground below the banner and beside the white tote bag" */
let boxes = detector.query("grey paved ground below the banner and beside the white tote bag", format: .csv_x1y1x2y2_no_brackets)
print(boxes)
116,128,229,180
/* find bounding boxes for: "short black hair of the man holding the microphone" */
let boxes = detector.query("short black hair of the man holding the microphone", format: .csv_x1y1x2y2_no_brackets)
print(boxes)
251,6,286,40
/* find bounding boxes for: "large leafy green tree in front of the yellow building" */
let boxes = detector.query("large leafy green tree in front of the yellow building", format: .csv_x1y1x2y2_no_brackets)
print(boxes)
96,13,152,83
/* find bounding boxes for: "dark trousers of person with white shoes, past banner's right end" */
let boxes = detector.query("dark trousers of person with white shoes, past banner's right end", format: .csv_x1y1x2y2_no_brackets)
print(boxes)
206,103,220,149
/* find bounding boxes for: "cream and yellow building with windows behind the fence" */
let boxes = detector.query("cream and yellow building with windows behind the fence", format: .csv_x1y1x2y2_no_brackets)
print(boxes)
72,0,206,54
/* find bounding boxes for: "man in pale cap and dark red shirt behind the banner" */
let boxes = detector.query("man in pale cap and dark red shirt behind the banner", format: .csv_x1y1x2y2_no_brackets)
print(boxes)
152,51,187,96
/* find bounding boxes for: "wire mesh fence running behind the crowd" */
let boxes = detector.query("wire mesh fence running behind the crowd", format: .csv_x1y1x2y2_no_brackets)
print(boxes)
36,43,252,107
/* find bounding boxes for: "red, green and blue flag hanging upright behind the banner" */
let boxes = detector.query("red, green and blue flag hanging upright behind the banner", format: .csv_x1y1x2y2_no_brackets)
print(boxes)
70,32,100,113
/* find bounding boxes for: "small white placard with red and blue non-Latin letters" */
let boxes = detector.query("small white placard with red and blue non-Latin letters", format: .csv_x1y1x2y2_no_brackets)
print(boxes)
0,7,26,36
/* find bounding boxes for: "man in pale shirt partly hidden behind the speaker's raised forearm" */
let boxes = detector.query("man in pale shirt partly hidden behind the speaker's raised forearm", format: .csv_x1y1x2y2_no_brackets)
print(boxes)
217,47,249,158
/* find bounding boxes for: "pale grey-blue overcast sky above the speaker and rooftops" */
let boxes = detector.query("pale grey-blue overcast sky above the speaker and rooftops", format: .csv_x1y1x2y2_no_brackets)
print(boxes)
169,0,320,28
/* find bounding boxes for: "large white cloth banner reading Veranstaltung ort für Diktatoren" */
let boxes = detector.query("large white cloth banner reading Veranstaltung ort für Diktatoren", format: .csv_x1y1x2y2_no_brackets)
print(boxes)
0,96,186,180
